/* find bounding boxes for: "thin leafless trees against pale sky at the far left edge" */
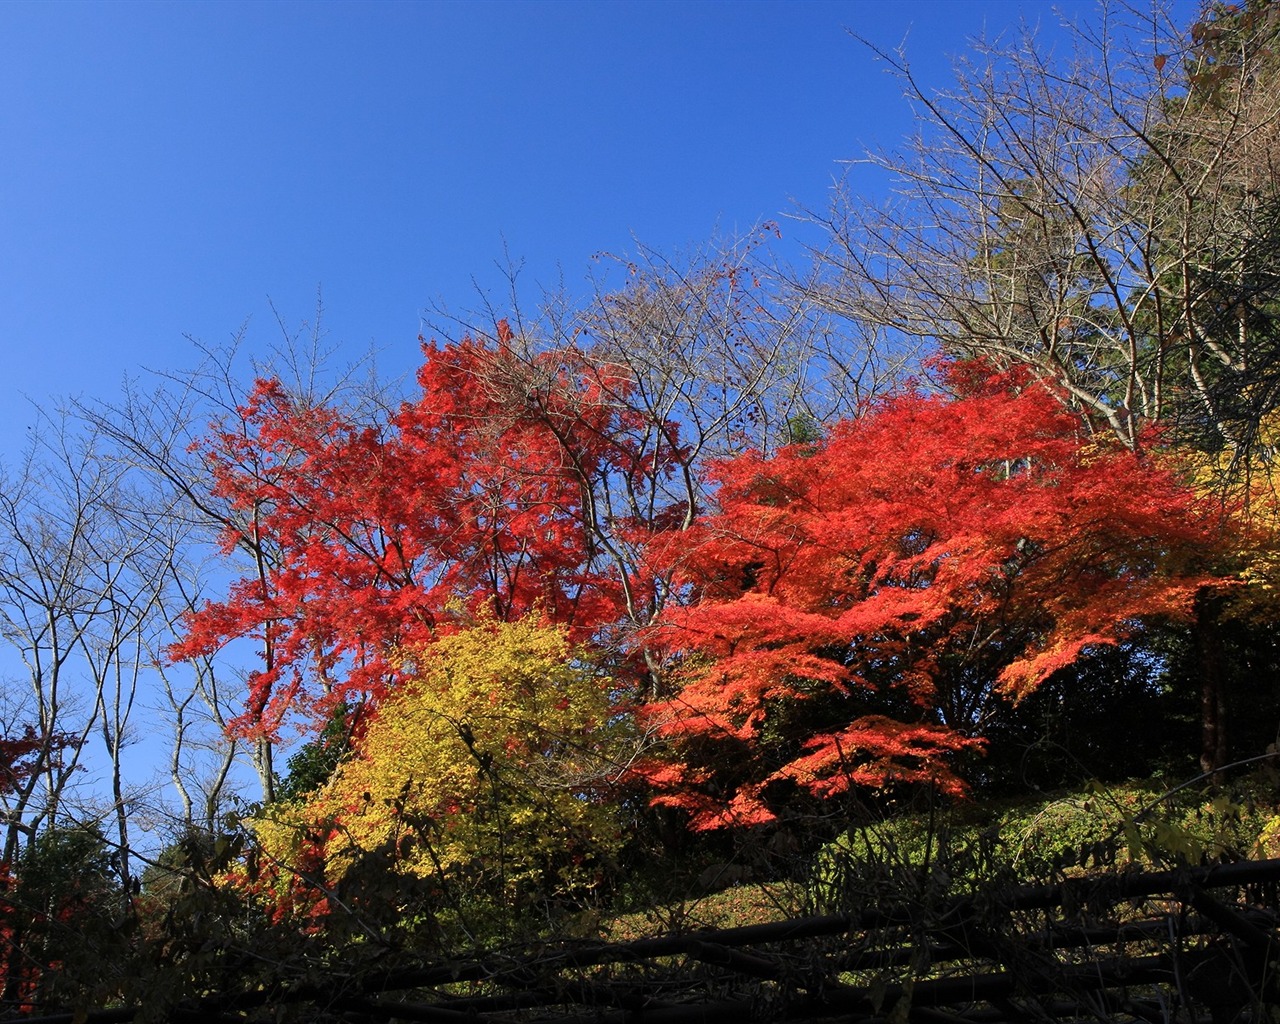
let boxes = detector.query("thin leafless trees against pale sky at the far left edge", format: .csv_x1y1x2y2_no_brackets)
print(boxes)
0,415,172,877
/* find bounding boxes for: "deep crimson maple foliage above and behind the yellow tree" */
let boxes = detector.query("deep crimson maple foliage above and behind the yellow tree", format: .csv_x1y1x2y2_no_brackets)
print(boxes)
174,324,677,736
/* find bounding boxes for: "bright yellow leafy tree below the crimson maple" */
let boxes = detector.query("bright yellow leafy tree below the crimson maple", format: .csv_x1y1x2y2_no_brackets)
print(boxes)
255,618,622,897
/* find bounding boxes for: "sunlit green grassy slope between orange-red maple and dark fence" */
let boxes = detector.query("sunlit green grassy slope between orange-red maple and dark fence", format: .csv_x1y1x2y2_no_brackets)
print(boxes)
599,767,1280,941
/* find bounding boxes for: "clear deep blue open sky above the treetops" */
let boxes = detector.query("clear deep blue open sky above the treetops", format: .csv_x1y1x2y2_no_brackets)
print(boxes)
0,0,1172,440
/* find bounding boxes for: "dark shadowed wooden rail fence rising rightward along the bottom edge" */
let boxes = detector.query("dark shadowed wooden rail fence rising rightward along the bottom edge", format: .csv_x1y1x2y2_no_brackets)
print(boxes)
12,859,1280,1024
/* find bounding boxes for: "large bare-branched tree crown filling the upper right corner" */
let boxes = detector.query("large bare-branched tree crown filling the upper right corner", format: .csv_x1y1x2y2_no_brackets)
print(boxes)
809,5,1280,447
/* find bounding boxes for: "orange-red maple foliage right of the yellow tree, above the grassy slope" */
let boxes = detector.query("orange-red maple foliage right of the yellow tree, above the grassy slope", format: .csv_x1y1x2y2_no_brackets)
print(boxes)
648,365,1217,828
